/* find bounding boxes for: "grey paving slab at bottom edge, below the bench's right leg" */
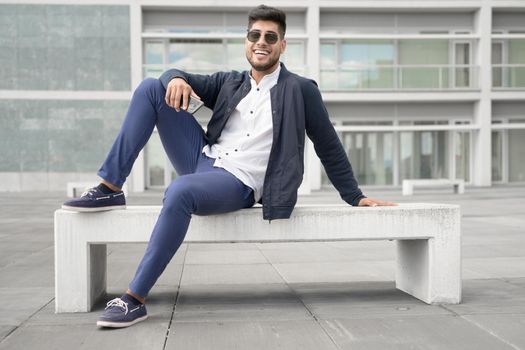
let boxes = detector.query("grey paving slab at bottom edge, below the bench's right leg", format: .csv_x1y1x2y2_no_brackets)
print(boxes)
322,315,515,350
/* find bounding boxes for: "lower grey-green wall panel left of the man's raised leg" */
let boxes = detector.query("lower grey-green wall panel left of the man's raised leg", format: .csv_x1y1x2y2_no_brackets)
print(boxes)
0,100,128,173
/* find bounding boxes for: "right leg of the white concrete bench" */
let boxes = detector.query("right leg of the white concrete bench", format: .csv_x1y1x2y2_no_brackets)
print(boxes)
396,238,461,304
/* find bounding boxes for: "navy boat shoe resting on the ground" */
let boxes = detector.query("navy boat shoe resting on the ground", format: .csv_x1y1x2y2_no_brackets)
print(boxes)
97,298,148,328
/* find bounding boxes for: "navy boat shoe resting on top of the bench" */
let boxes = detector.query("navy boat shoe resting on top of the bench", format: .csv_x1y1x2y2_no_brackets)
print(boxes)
62,187,126,212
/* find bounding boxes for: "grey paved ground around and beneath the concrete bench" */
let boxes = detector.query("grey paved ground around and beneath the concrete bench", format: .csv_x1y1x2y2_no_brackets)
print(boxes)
0,186,525,350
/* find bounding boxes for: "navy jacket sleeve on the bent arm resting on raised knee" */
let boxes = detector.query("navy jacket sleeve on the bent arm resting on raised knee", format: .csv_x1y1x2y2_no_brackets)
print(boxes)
159,69,231,109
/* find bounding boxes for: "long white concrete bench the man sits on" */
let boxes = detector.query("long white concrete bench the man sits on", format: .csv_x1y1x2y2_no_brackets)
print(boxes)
55,204,461,313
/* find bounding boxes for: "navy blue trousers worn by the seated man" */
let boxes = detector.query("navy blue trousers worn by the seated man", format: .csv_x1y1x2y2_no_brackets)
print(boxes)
98,78,254,297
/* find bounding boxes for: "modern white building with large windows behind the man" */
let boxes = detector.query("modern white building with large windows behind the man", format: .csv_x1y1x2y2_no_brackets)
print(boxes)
0,0,525,192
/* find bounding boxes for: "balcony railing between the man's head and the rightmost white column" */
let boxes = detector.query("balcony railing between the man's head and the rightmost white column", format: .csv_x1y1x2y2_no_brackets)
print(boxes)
320,65,479,91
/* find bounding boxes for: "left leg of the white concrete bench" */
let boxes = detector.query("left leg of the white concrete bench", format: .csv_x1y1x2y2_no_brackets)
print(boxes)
55,227,107,313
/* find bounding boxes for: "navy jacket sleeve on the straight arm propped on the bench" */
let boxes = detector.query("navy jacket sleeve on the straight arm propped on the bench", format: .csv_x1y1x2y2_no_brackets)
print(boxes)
302,80,365,206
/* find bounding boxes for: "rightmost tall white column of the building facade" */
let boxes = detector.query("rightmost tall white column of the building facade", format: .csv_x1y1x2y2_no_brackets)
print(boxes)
472,0,492,186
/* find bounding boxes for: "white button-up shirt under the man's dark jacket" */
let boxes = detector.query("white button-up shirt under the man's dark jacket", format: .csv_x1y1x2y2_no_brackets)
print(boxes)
202,65,281,202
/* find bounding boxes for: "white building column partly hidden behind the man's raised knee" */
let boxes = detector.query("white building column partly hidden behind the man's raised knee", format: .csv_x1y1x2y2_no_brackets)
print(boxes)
128,3,146,192
